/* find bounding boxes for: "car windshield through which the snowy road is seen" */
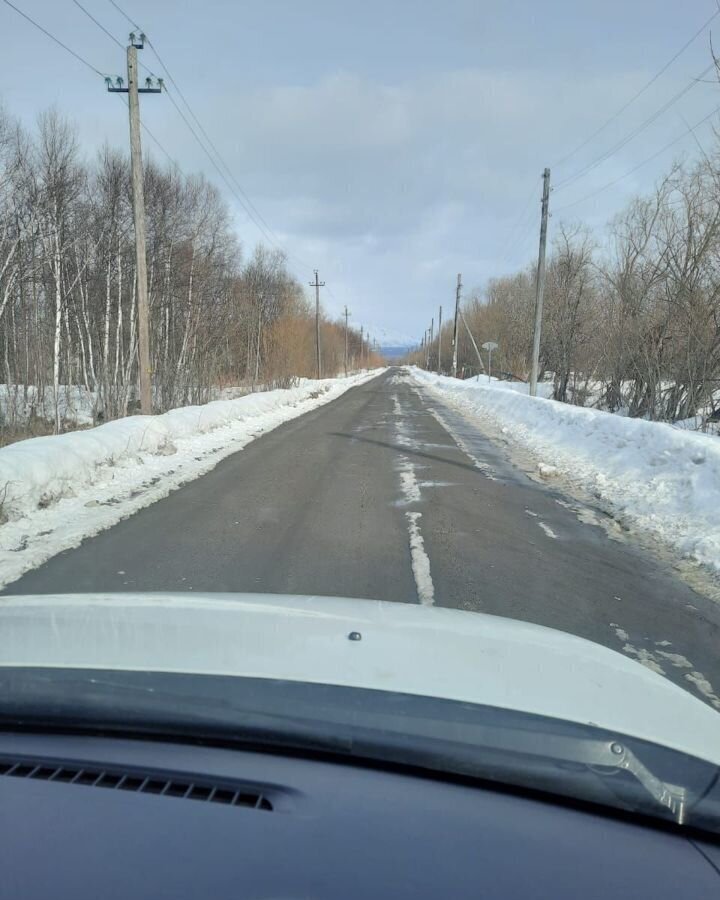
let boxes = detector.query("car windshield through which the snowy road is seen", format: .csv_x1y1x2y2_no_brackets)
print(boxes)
0,0,720,831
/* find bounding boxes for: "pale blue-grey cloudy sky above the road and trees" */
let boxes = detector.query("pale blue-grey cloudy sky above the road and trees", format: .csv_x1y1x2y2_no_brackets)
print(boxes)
0,0,720,342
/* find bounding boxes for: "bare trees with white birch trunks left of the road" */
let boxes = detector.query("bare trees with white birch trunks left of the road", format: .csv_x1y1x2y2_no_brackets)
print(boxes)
0,104,380,433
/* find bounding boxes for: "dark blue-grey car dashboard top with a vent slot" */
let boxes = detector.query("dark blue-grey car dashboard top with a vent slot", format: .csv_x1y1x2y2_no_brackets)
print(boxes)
0,732,720,900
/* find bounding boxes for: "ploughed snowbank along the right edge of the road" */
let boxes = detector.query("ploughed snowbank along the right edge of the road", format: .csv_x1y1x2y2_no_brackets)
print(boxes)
411,368,720,572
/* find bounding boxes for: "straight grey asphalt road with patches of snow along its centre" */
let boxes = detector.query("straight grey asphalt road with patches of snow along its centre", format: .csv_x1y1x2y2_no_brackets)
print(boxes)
5,370,720,708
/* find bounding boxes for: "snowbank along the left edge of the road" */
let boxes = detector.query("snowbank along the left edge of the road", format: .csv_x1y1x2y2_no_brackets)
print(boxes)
0,369,382,587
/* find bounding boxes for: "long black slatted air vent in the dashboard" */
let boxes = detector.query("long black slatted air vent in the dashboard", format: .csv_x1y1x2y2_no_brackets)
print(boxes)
0,759,273,811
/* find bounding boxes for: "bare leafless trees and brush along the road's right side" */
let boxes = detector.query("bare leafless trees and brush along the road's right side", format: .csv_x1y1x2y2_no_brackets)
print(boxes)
413,153,720,422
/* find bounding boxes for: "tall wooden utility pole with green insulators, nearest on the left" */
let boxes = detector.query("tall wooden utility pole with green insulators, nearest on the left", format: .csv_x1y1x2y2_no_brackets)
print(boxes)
105,32,163,416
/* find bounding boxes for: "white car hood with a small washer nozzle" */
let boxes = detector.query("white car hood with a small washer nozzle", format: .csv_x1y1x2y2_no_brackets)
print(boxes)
0,593,720,765
